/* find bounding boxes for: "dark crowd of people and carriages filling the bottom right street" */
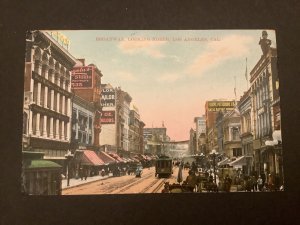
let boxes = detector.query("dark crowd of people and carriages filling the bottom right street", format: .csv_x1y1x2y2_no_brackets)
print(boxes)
162,162,283,193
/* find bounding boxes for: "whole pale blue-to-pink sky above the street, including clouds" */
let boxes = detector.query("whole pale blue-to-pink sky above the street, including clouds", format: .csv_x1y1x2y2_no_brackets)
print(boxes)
54,30,276,141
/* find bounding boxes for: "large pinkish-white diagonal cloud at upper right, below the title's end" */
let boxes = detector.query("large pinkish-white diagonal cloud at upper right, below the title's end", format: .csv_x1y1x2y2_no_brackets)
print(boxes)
186,35,254,76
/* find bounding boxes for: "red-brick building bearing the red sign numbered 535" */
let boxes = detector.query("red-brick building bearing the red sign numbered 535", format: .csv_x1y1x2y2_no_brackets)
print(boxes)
72,59,103,149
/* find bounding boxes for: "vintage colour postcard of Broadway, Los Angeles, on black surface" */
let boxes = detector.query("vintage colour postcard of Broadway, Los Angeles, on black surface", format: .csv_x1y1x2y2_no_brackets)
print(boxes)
22,30,284,195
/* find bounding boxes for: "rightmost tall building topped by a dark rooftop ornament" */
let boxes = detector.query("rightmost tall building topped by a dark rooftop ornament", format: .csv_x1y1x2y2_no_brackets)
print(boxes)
250,31,282,180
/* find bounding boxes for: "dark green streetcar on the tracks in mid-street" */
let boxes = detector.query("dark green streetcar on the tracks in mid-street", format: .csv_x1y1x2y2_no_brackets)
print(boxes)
155,156,173,178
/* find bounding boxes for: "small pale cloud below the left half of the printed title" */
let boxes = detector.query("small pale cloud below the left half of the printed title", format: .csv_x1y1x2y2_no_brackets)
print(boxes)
118,40,166,58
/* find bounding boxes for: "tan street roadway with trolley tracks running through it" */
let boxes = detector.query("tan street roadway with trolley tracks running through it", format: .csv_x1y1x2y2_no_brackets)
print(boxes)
62,167,188,195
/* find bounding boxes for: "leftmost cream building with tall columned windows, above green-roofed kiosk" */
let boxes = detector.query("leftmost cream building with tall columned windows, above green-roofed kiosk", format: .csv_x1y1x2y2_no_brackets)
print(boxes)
23,31,76,164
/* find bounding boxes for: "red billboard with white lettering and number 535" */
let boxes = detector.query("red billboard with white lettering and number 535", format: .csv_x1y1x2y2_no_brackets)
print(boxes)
72,66,94,89
